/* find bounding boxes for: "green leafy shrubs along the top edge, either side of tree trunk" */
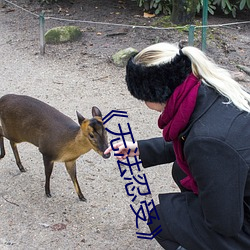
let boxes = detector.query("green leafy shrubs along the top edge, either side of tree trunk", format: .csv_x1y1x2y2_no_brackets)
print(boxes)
135,0,250,17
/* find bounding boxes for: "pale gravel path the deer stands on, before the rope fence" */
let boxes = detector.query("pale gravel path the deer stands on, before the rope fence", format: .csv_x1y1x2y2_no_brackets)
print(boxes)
0,3,176,250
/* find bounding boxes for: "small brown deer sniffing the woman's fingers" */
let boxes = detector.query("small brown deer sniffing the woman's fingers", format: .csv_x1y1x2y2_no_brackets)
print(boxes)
0,94,110,201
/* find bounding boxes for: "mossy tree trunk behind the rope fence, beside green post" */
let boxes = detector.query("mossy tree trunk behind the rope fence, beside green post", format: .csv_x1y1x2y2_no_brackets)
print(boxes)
171,0,198,25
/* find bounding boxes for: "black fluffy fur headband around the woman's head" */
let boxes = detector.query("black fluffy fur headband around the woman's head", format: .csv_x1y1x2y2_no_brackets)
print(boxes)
126,51,192,103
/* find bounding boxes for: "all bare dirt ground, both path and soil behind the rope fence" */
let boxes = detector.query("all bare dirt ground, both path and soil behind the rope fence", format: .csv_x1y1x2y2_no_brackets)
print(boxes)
0,0,250,250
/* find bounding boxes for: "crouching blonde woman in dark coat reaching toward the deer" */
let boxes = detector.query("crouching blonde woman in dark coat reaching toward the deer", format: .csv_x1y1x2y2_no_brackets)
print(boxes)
105,43,250,250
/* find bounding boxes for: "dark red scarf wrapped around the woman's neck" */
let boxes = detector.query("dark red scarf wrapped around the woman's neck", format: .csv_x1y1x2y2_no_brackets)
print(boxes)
158,73,200,194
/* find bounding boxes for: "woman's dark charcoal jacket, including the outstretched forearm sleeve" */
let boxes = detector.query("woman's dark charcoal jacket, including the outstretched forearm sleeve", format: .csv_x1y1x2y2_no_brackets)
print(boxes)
138,85,250,250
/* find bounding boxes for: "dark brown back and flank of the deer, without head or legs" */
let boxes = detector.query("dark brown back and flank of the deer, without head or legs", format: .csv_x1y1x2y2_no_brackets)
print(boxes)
0,94,79,147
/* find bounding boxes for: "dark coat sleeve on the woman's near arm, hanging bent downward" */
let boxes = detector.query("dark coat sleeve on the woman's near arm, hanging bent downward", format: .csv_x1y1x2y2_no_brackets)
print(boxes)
184,137,248,237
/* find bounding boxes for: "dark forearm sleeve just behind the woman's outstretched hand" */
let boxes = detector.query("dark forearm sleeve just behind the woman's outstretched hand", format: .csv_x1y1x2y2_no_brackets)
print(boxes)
138,137,175,168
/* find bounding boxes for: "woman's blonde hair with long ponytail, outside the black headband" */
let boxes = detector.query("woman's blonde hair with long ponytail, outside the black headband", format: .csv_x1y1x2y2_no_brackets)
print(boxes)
134,43,250,113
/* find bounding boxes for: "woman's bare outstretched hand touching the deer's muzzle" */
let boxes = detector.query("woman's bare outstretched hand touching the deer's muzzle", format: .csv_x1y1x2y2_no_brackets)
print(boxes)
104,141,140,160
